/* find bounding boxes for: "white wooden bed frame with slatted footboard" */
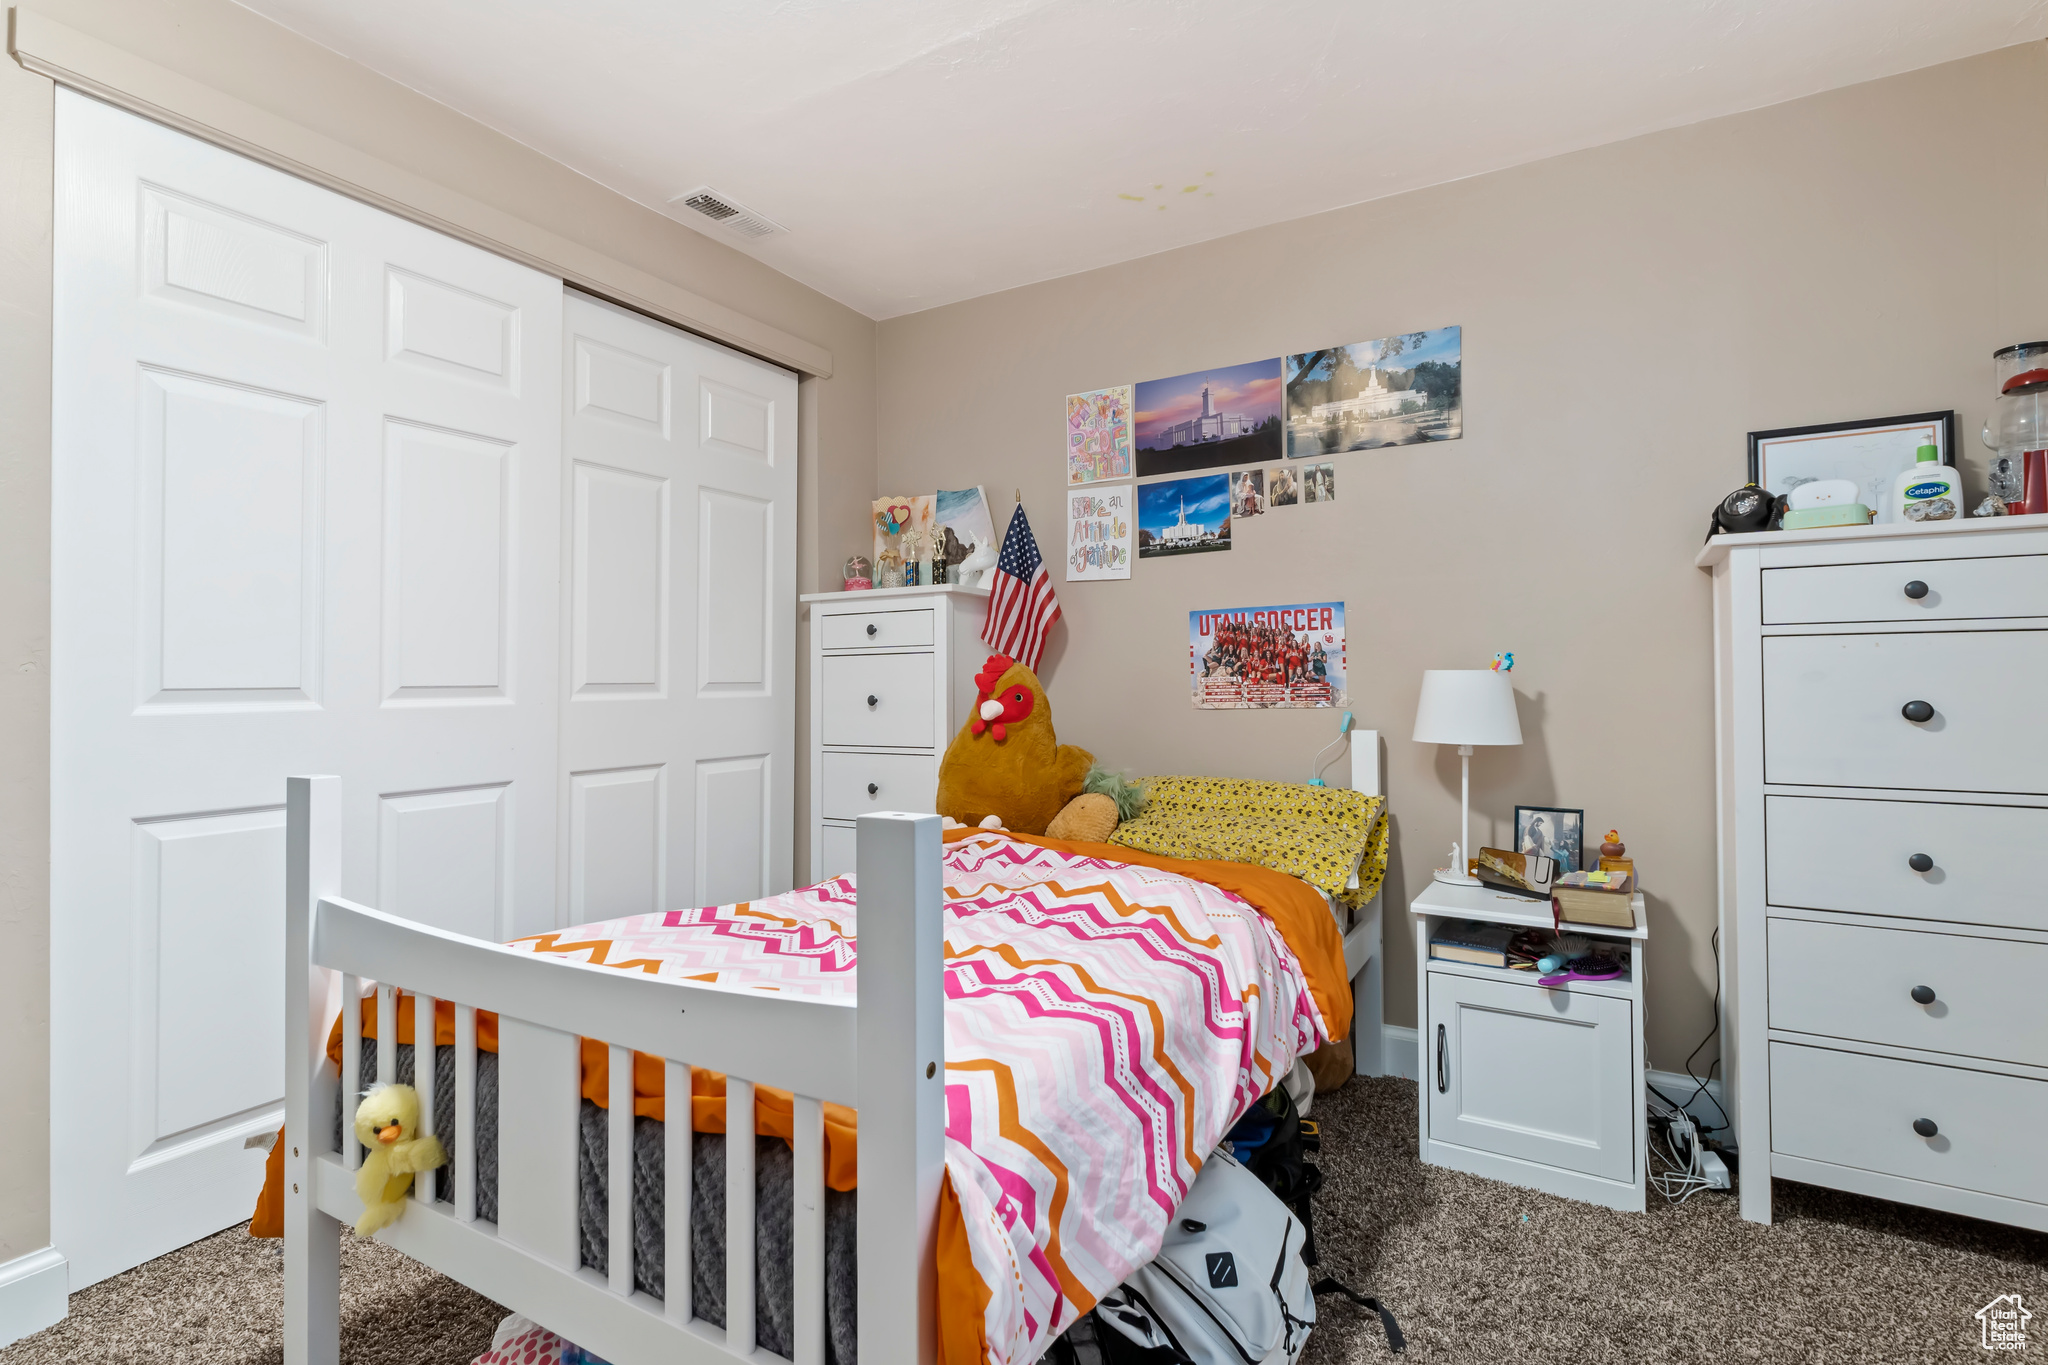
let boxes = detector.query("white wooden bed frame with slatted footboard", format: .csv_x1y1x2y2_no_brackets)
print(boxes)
283,731,1384,1365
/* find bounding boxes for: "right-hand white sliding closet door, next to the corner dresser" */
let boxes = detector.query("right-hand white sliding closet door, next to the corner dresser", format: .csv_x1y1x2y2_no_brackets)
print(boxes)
561,293,797,923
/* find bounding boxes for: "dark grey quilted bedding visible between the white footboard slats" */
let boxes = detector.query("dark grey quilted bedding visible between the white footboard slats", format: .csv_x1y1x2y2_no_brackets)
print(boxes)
350,1038,858,1365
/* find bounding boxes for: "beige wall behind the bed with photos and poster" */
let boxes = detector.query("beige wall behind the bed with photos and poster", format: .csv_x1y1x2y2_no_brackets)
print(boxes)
872,43,2048,1070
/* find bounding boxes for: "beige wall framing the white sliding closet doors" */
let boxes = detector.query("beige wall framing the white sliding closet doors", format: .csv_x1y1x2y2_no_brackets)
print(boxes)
0,0,874,1265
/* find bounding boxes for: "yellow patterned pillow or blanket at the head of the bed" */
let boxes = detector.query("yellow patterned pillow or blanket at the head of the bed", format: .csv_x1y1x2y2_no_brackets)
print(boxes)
1110,778,1389,909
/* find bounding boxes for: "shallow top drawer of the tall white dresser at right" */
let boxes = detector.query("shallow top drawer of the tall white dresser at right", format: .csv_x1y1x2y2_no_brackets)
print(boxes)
1763,555,2048,626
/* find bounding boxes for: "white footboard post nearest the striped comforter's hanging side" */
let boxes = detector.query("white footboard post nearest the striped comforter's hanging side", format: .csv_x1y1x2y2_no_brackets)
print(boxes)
854,812,946,1365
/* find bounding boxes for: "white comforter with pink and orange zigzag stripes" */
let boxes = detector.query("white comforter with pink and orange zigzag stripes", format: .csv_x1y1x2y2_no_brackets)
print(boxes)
501,835,1341,1365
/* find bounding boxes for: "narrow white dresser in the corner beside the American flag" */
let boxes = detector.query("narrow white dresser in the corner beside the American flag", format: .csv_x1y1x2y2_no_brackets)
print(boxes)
803,587,989,882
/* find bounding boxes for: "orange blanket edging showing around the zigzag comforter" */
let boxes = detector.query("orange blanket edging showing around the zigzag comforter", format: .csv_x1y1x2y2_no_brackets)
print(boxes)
250,829,1352,1365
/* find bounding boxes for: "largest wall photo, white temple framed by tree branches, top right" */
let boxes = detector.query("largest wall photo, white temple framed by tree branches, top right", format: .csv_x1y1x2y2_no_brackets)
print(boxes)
1284,327,1464,458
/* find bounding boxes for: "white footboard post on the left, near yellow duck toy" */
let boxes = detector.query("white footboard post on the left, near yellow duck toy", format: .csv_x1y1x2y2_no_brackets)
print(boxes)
281,778,342,1365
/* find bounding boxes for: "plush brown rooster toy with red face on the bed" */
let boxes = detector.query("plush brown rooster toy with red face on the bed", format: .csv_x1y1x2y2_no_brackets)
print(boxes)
938,655,1096,835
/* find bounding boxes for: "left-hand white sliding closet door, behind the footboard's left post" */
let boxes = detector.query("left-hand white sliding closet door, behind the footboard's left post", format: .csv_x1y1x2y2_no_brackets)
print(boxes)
51,90,561,1289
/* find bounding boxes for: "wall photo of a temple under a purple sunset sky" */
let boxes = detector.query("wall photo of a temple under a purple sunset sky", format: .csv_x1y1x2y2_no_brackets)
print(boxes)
1135,358,1284,479
